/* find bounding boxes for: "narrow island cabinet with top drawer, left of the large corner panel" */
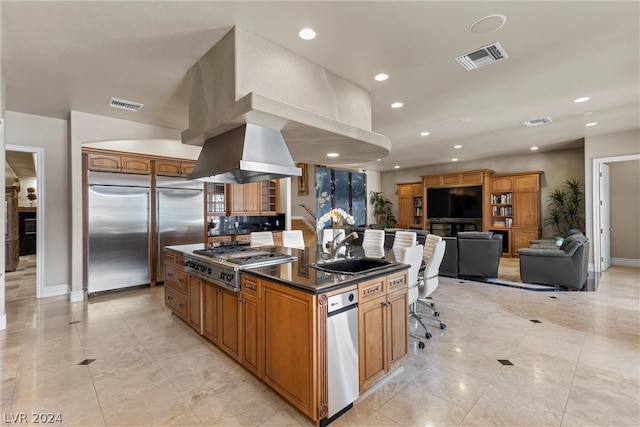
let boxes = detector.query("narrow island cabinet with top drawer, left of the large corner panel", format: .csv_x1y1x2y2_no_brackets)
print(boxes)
240,276,264,377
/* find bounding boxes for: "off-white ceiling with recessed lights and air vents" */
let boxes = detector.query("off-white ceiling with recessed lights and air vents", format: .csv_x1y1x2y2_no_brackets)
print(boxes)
0,0,640,171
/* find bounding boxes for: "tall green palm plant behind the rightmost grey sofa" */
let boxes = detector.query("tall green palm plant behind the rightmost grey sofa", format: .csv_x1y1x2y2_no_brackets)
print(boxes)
543,178,584,246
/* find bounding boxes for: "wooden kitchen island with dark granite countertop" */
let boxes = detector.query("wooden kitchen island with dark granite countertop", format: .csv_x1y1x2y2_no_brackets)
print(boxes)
165,244,408,424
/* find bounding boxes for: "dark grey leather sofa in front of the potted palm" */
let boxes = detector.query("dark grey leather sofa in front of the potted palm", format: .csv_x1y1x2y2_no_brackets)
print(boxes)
518,233,589,289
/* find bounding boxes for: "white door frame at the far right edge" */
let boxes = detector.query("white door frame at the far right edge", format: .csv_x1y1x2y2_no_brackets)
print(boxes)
592,154,640,273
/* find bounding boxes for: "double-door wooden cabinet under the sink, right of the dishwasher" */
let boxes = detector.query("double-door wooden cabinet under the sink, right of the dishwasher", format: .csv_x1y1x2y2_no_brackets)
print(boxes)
358,272,409,393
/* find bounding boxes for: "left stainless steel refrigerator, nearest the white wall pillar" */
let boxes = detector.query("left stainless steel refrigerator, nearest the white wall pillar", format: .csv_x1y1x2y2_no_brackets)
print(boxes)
86,172,151,293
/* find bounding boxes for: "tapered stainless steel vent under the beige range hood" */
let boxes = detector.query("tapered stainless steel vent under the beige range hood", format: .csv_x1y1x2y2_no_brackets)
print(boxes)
187,123,302,184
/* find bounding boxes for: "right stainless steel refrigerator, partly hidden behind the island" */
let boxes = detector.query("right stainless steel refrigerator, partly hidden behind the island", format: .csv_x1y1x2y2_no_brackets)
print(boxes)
156,176,204,282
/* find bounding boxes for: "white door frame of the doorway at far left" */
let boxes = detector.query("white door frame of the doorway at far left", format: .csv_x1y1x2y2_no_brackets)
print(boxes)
4,144,47,298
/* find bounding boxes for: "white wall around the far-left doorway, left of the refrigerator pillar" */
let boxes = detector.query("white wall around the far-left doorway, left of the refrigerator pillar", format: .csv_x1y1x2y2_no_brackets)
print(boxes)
2,111,70,294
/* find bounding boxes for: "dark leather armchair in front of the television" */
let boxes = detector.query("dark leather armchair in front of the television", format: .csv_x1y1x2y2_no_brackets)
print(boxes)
440,231,502,279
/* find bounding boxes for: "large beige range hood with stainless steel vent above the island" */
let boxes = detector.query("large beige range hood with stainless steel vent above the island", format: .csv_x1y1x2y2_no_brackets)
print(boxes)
182,27,391,176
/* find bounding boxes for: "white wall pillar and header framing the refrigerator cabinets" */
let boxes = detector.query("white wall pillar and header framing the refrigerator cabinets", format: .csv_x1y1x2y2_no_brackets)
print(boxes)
71,111,184,302
